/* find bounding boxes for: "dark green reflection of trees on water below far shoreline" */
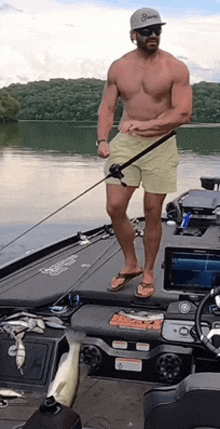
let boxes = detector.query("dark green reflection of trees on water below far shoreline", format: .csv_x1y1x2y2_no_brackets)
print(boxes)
0,121,220,155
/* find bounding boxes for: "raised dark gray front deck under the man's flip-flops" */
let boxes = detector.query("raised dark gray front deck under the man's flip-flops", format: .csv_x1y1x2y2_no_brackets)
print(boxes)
0,221,179,309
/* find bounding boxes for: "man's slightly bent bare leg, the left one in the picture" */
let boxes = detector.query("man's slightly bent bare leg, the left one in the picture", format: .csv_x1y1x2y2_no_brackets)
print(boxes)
107,185,143,289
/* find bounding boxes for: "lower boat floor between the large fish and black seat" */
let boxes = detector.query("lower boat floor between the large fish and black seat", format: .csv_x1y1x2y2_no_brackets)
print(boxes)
73,377,155,429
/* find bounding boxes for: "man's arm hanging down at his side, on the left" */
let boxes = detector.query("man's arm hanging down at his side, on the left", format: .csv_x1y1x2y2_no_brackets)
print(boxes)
97,64,120,158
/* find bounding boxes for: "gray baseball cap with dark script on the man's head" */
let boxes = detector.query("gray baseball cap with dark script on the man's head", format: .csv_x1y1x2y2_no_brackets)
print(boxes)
130,7,166,30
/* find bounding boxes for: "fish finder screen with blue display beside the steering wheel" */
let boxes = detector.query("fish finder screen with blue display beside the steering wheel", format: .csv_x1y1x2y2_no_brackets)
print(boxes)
164,247,220,294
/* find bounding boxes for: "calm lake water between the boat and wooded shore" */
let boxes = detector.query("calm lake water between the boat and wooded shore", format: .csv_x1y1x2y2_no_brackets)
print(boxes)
0,121,220,265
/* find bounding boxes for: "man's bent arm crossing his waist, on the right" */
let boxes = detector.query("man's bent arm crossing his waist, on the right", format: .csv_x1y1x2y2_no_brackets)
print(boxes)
121,63,192,137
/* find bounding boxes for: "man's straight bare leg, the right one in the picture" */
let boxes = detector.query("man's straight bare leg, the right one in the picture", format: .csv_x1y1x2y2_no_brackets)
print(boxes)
138,192,166,296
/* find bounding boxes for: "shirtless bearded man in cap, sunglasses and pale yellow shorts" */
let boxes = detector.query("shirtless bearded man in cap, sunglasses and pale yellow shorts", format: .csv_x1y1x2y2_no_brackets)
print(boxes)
98,8,192,298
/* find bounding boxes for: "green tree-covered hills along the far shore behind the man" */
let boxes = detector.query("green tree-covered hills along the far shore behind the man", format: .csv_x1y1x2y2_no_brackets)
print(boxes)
0,78,220,123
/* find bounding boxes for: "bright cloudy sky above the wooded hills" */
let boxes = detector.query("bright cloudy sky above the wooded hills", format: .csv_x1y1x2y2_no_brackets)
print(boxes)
0,0,220,88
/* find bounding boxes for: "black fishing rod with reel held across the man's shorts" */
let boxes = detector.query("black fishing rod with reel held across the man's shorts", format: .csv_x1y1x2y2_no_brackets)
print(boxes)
0,131,176,251
